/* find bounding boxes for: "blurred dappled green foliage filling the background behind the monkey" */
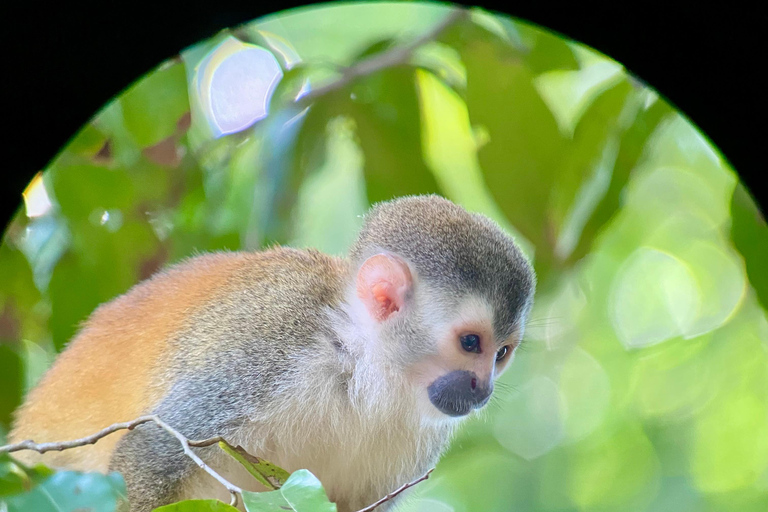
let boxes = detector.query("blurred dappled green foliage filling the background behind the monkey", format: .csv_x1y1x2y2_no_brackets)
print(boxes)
0,4,768,512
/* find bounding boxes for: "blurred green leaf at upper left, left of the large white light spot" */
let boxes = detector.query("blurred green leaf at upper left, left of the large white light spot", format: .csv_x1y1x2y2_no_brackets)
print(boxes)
120,62,189,148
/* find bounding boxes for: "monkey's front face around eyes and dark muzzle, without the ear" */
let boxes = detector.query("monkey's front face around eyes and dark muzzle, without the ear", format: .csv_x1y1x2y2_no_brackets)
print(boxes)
411,298,519,419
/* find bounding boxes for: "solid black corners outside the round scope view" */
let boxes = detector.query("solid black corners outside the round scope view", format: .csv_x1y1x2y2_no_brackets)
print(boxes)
0,0,768,227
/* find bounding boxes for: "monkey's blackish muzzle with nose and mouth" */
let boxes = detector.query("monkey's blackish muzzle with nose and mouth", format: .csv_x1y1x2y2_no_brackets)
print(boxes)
427,370,493,416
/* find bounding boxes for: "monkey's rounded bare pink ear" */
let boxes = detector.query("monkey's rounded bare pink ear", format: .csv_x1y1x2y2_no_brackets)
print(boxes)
357,254,413,322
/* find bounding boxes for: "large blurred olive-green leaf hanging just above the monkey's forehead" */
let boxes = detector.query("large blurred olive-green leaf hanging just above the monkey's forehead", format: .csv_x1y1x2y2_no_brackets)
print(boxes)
460,29,568,274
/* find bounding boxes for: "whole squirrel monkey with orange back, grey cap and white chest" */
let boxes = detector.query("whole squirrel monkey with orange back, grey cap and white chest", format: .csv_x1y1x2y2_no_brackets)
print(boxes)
10,196,535,512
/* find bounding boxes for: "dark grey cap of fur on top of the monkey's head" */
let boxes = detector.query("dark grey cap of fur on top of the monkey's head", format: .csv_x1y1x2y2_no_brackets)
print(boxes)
350,195,536,339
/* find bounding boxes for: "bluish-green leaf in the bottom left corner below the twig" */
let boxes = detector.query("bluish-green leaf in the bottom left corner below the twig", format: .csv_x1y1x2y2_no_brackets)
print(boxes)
3,471,126,512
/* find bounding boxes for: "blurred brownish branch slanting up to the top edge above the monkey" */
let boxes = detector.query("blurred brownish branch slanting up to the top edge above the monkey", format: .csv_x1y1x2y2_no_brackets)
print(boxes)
297,7,469,108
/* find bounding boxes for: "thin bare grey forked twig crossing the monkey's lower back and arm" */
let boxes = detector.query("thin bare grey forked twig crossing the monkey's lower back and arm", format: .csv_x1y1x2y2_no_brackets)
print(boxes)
0,414,243,506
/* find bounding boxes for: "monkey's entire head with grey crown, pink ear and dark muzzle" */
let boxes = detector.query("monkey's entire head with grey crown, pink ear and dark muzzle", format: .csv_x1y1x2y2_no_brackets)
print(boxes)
350,196,535,420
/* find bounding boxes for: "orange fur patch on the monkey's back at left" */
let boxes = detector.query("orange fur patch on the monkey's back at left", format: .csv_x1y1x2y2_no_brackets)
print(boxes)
10,253,249,471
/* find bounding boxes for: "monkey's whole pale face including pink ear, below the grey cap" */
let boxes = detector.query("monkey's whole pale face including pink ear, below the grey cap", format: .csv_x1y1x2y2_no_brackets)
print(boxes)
355,252,526,421
